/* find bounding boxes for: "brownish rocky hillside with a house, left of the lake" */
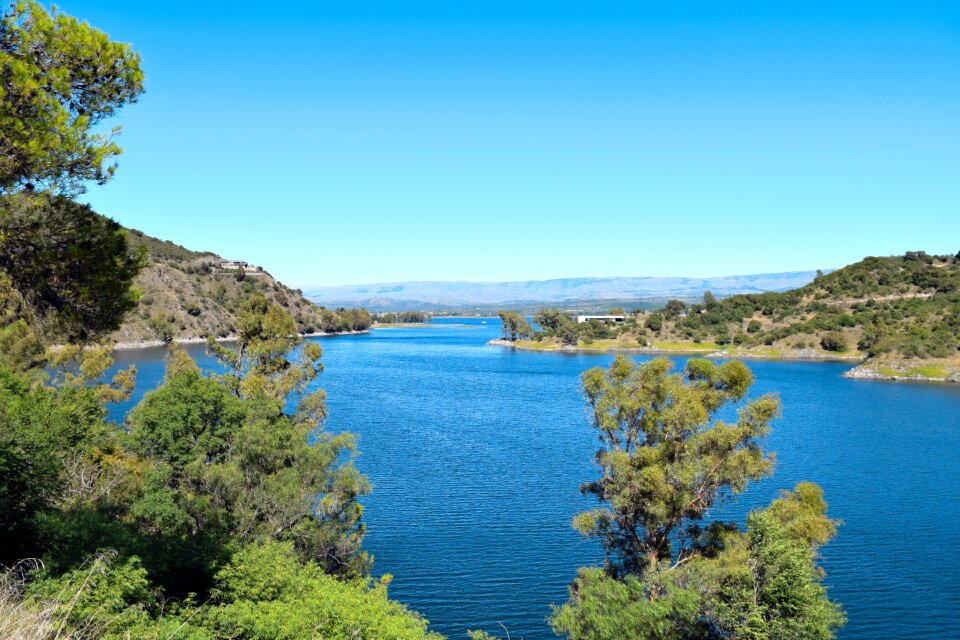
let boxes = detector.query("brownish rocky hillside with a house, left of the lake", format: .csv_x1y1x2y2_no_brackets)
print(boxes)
110,229,371,343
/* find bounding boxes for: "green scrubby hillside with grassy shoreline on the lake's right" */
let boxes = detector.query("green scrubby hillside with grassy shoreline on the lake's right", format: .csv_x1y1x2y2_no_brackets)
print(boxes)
516,251,960,379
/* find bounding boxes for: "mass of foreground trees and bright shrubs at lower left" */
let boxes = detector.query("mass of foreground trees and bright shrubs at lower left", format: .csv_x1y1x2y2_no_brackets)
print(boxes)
0,282,444,638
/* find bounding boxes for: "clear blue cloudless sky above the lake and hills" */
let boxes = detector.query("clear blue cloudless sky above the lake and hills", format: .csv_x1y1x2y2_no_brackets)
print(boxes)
60,0,960,285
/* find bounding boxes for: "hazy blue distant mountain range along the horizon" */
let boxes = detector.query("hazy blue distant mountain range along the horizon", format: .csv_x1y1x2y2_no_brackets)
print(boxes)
303,271,816,310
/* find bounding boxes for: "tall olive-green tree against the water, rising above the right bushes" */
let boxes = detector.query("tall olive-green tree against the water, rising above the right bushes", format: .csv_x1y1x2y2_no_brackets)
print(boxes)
575,356,780,575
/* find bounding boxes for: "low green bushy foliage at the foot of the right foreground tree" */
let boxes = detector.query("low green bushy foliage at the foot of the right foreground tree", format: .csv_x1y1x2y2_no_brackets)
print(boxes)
551,483,845,640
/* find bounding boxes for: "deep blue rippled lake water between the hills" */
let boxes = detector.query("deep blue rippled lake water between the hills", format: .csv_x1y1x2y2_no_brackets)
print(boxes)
107,319,960,640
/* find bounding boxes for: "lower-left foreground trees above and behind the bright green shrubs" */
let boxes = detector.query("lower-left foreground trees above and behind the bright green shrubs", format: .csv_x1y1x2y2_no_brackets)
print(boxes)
0,300,370,616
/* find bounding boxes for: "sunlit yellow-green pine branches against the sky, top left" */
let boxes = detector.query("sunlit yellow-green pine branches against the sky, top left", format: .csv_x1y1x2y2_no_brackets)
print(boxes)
0,0,143,195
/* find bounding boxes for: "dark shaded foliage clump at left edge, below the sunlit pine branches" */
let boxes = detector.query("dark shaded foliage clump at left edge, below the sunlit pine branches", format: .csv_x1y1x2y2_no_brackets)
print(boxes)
0,195,143,341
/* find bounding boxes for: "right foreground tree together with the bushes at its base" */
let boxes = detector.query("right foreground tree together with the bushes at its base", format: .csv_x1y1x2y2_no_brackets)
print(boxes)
551,357,844,640
